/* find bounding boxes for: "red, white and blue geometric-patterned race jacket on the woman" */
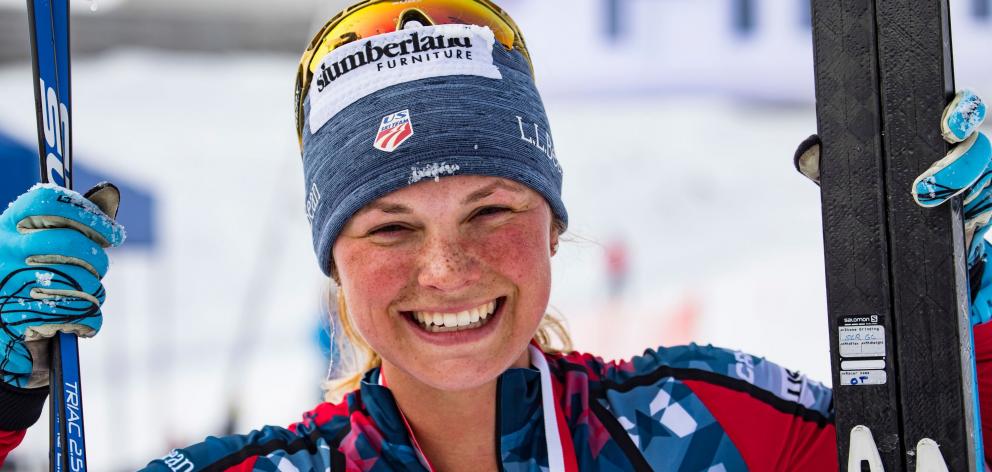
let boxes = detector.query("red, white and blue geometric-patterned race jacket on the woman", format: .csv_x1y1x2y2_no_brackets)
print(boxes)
0,324,992,472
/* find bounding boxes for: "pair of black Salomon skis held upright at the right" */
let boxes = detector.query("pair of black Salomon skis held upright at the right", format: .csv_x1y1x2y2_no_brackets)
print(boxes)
812,0,984,471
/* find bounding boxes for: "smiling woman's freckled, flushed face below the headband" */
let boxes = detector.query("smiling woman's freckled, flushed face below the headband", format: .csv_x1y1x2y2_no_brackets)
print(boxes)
333,176,558,391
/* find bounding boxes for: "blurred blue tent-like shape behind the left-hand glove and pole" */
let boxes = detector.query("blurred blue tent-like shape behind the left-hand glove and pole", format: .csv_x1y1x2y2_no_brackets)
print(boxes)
0,131,157,250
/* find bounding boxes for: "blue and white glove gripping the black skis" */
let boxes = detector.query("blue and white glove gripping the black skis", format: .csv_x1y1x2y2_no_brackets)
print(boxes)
794,90,992,324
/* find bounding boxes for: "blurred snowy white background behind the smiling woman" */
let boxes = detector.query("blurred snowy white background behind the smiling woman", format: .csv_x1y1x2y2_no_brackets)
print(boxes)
0,0,992,471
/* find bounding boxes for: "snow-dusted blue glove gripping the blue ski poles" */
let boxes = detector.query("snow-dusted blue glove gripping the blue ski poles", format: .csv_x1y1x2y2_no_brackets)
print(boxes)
0,183,125,388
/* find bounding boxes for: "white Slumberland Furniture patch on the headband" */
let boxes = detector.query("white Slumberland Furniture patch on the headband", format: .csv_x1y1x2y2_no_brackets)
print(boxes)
308,25,503,133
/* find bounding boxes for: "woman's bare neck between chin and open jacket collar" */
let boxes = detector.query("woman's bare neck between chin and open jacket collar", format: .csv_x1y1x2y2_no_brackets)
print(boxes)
382,351,529,472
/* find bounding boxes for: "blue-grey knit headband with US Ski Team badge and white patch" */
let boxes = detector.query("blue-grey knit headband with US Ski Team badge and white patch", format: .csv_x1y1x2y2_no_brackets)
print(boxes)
303,25,568,275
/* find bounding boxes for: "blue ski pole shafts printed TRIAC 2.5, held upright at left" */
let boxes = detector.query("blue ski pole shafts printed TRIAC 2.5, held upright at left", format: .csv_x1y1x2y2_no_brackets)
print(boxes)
27,0,86,472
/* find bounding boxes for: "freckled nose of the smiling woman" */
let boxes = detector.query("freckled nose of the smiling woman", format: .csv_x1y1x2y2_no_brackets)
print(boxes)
418,232,482,292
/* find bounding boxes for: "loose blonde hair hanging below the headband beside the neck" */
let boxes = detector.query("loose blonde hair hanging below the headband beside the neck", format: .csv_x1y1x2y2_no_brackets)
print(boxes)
323,287,572,403
